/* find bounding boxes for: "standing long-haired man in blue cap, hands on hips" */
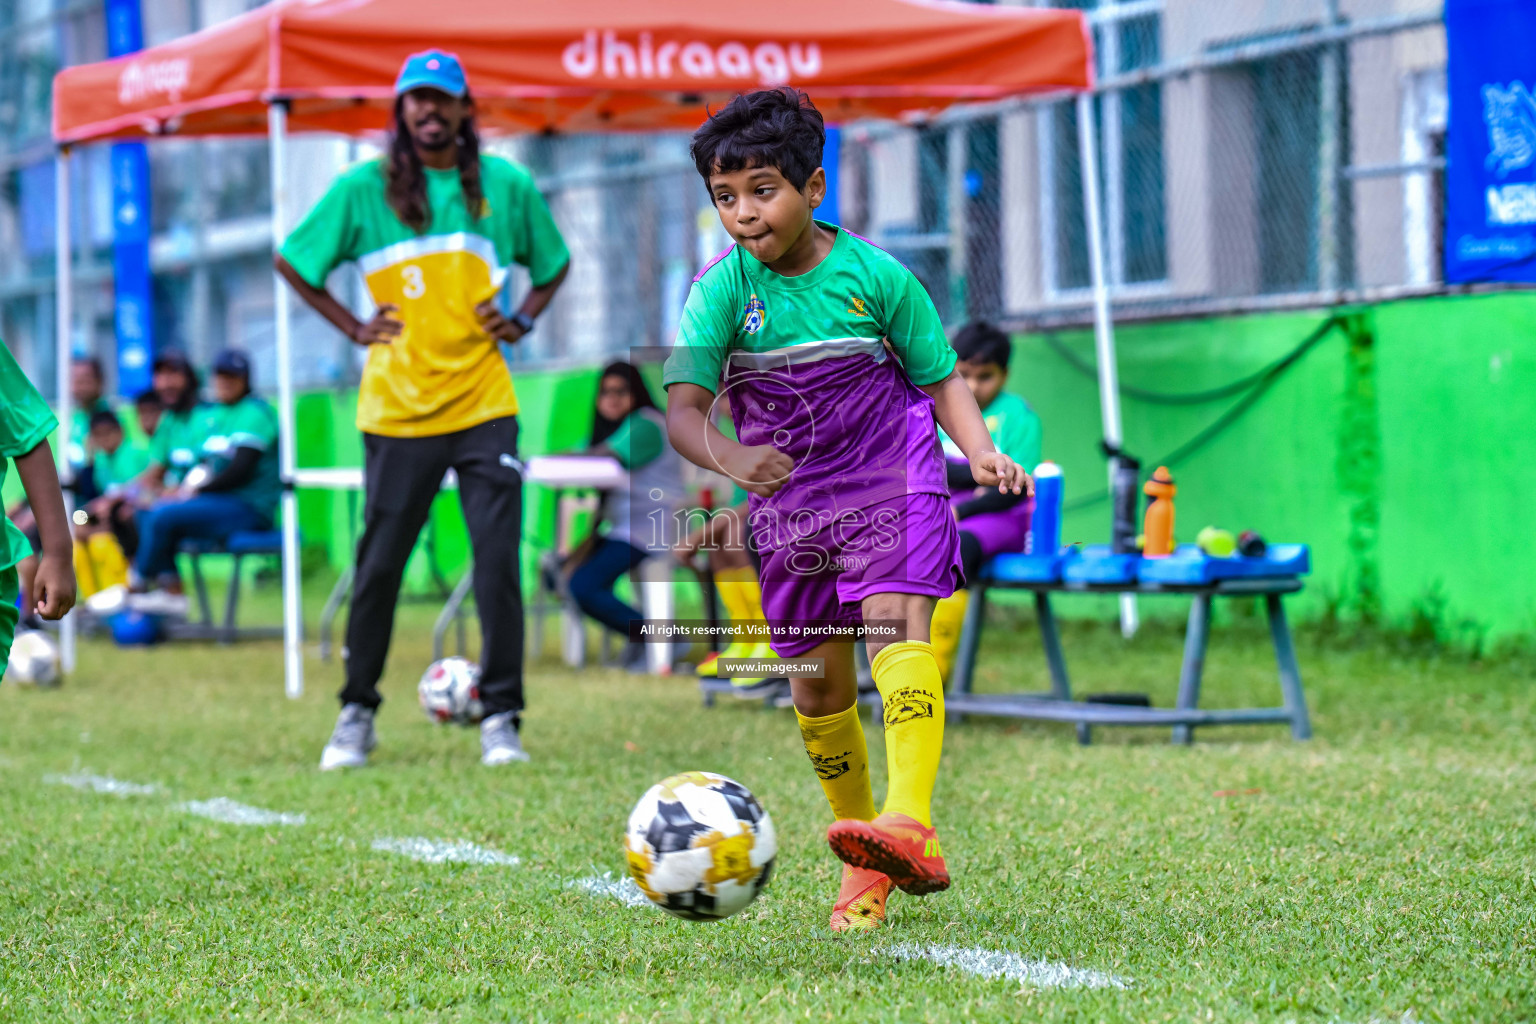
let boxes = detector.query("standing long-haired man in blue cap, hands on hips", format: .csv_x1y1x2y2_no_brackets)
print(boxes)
276,51,570,769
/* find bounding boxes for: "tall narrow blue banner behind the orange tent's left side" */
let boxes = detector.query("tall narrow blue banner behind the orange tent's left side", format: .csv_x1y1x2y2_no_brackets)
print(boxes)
106,0,155,396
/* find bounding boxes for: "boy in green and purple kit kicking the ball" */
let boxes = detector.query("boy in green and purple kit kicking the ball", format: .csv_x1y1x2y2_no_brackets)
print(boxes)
664,89,1031,930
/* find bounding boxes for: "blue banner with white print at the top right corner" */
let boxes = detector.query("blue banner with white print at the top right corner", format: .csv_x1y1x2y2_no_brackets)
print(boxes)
1445,0,1536,282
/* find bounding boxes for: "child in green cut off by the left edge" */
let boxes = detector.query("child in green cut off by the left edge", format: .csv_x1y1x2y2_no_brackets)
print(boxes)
0,336,75,663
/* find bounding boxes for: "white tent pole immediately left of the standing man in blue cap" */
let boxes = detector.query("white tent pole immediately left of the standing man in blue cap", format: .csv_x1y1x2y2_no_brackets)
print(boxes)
267,100,304,700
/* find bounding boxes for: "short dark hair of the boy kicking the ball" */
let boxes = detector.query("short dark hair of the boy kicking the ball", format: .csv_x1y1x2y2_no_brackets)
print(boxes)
688,86,826,189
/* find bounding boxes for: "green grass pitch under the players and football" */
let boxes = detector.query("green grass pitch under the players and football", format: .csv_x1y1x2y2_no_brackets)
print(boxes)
0,595,1536,1022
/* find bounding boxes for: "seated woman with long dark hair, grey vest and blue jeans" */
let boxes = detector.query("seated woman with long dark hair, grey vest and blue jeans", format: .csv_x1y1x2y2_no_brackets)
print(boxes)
564,362,682,671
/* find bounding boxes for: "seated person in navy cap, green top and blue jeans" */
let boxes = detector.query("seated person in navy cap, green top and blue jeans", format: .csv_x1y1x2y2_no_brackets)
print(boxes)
131,348,283,614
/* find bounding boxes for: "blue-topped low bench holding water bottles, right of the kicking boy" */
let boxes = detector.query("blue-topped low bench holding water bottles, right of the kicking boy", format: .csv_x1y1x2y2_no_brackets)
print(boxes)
945,543,1312,743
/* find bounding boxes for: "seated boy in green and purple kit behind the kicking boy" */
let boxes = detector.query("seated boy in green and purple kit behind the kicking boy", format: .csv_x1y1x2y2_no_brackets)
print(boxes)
931,321,1040,680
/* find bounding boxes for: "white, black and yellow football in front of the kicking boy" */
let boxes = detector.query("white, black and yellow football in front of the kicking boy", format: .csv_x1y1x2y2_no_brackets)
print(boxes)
624,772,779,921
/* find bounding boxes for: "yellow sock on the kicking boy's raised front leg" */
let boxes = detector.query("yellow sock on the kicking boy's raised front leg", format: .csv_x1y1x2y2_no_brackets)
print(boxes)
869,640,945,826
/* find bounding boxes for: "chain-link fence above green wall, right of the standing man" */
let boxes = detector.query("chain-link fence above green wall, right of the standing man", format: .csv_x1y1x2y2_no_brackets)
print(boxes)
493,0,1445,362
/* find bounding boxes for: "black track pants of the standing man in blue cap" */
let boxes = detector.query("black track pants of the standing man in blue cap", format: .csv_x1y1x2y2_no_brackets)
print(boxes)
341,416,522,714
